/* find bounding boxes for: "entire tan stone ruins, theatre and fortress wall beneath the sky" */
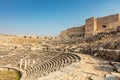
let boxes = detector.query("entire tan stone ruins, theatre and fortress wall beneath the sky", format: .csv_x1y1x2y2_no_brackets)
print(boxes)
0,14,120,80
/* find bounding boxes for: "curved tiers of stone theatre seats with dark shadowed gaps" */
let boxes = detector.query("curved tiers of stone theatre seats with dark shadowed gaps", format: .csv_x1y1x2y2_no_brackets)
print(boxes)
25,53,81,77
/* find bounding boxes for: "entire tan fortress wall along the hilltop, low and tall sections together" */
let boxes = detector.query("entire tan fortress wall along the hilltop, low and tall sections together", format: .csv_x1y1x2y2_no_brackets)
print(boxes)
60,14,120,36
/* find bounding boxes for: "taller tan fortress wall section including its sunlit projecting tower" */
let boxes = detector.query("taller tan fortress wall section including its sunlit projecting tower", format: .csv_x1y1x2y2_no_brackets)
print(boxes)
85,14,120,35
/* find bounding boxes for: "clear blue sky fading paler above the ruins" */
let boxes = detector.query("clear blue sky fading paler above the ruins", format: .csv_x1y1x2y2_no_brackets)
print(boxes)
0,0,120,35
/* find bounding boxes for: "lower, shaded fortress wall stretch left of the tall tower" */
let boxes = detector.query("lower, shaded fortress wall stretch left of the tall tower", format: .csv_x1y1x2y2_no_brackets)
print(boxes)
60,26,85,36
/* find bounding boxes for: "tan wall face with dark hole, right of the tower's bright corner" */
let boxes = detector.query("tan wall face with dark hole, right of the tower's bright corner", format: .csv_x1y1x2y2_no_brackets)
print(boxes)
96,14,120,33
